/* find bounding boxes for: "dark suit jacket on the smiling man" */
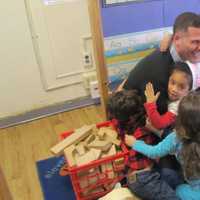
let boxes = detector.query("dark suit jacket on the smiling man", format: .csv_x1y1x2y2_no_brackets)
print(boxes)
124,50,174,114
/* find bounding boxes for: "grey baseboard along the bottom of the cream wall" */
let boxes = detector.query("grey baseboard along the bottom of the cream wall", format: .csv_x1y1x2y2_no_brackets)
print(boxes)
0,97,100,128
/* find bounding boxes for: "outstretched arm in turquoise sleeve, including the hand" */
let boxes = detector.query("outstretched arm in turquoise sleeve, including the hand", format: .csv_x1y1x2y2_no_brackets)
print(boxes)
125,133,177,159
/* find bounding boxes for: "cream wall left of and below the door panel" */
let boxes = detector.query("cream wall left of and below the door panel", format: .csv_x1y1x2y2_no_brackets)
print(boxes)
0,0,92,118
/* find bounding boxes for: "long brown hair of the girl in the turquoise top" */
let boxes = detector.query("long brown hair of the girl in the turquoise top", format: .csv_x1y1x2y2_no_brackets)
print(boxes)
176,89,200,179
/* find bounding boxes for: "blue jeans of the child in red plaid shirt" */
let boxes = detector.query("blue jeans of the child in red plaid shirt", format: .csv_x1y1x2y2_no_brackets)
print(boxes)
128,170,180,200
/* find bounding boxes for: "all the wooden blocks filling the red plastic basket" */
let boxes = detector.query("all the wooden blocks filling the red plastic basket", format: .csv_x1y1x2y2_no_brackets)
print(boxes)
51,125,124,194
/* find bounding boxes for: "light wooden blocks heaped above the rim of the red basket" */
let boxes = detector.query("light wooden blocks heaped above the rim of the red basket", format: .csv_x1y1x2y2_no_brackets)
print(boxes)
51,125,120,167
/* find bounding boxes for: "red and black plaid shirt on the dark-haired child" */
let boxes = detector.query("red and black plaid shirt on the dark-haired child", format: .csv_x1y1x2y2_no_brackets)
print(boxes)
112,119,156,170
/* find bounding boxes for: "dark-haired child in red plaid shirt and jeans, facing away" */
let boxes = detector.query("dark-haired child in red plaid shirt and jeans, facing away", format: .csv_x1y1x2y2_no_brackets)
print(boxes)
107,90,179,200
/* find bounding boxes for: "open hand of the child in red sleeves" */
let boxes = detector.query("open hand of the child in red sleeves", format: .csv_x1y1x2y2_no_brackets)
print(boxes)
144,82,160,103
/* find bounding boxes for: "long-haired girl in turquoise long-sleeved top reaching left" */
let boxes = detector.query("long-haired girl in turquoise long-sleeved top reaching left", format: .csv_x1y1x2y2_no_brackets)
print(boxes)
125,89,200,200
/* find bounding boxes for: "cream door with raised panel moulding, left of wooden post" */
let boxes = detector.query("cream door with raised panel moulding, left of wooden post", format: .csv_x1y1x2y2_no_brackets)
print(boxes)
25,0,91,90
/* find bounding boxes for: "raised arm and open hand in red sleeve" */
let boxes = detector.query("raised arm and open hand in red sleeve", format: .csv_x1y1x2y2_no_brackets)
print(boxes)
144,83,176,129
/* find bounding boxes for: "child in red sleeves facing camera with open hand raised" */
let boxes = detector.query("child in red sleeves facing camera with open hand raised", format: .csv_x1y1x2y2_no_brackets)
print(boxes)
144,62,193,129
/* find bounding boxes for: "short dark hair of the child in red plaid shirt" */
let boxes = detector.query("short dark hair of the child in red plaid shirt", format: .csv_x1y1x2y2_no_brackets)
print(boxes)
107,90,146,134
